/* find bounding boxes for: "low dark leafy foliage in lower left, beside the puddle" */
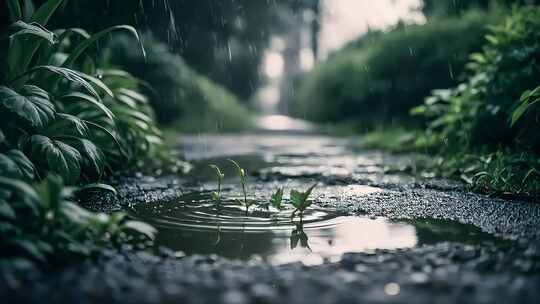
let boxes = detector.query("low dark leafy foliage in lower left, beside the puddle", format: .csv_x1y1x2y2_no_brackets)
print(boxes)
0,175,155,264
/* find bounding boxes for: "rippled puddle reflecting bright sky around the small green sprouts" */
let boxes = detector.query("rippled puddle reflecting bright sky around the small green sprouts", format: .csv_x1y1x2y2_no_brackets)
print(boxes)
131,194,497,265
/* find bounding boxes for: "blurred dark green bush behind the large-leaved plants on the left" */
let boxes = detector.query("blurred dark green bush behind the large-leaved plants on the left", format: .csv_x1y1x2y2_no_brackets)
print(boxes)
105,35,251,131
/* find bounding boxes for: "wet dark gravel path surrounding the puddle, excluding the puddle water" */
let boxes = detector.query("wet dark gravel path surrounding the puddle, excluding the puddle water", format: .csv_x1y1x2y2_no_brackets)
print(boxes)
0,134,540,304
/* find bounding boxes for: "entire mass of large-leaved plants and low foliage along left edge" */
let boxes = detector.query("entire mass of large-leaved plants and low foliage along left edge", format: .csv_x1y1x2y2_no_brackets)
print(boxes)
0,0,160,267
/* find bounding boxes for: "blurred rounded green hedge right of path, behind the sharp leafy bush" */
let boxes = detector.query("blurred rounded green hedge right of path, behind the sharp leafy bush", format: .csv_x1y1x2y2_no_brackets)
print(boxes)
292,12,496,126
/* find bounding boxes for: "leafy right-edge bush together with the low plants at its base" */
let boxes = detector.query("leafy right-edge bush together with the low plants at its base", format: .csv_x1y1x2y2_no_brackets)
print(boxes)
412,7,540,195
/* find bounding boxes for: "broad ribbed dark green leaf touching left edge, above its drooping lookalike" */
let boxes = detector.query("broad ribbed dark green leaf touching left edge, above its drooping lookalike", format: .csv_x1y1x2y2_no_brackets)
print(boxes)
0,85,55,129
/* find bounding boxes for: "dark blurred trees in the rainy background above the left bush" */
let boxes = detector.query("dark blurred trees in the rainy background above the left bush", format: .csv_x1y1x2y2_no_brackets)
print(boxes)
4,0,319,99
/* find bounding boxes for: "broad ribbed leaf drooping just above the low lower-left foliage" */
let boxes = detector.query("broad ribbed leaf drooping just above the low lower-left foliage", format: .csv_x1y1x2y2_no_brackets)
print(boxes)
30,135,82,183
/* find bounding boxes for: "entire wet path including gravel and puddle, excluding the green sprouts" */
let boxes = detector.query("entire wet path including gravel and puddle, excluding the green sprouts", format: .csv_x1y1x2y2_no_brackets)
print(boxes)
0,120,540,303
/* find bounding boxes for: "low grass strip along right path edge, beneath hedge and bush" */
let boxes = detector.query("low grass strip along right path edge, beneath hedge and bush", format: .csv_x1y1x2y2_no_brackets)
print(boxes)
357,127,540,200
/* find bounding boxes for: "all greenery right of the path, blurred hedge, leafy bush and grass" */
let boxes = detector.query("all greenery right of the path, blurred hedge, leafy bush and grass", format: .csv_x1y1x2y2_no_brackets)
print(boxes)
297,6,540,199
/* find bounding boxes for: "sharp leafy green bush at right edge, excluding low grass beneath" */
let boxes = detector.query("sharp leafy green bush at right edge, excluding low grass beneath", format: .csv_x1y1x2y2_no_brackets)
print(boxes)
413,7,540,151
